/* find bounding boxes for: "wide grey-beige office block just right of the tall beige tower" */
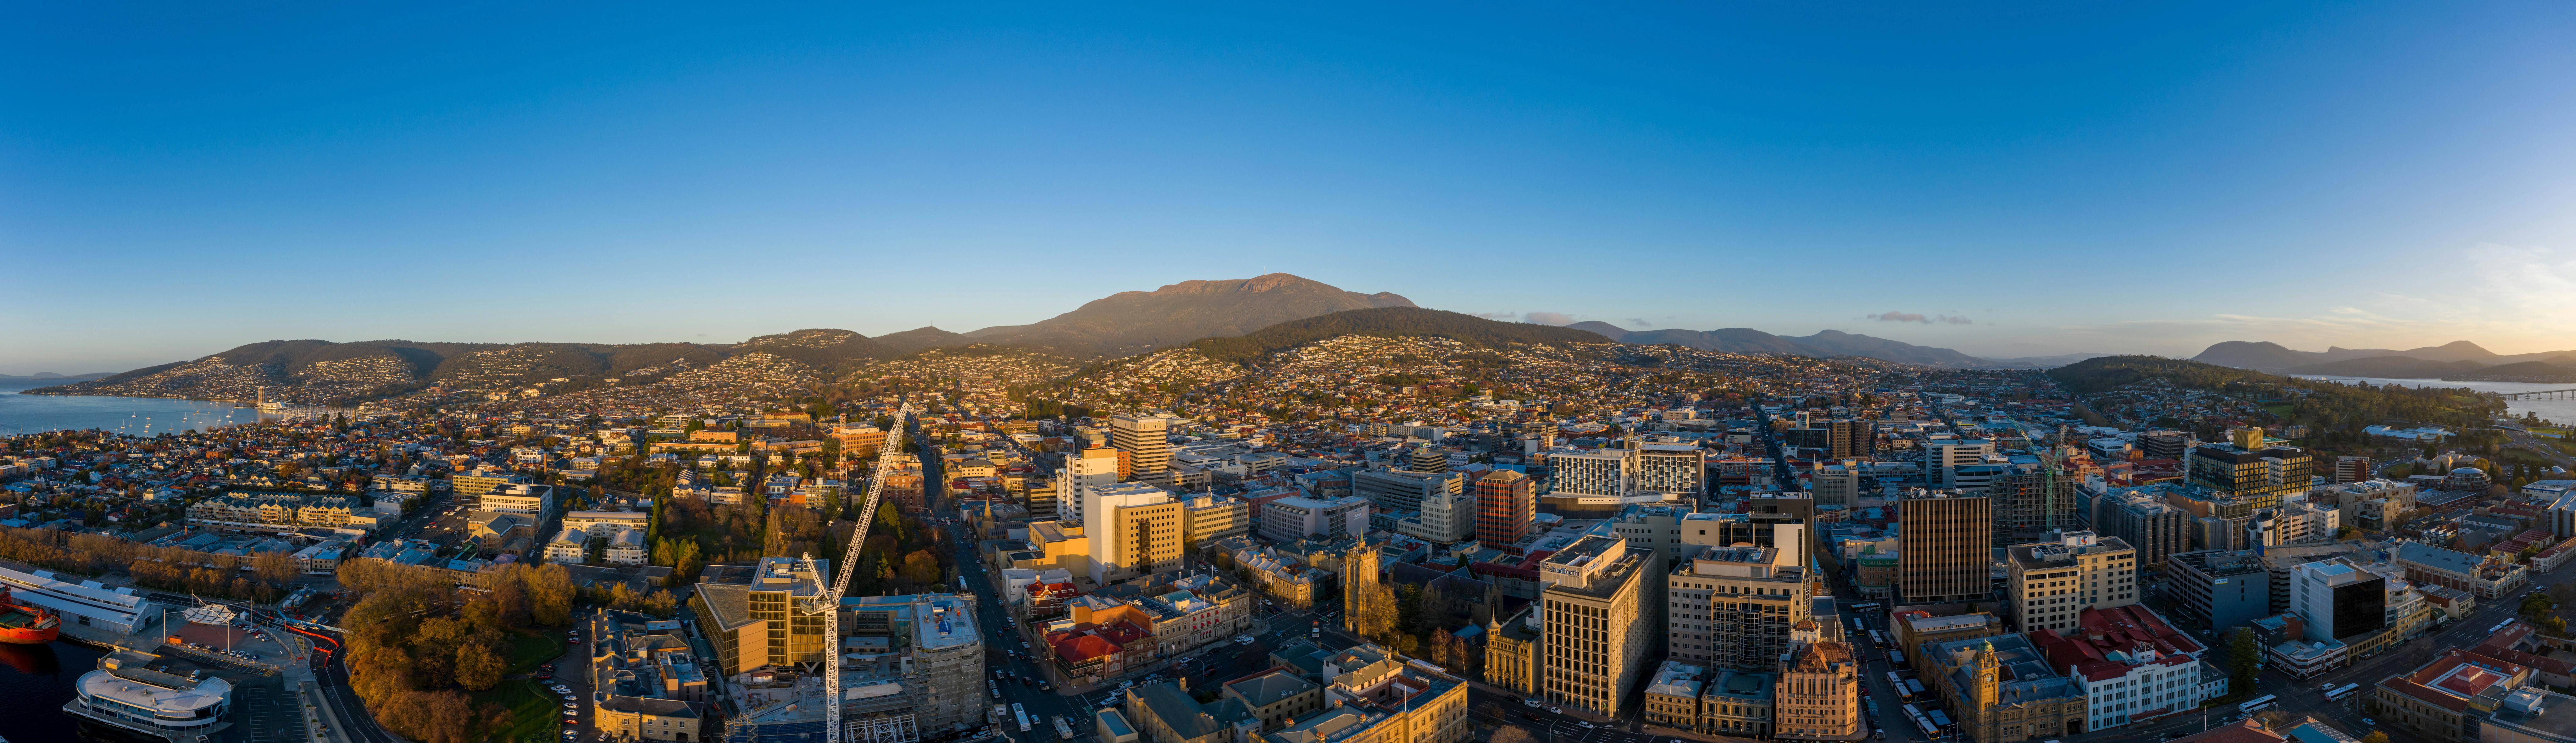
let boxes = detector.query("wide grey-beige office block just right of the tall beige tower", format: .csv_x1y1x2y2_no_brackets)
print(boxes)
1664,539,1813,673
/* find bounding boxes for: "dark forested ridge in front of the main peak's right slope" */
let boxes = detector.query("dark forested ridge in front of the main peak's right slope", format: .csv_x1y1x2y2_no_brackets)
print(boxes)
1190,307,1602,364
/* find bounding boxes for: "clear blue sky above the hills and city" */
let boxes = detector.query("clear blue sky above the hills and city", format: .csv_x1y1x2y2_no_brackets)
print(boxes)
0,3,2576,374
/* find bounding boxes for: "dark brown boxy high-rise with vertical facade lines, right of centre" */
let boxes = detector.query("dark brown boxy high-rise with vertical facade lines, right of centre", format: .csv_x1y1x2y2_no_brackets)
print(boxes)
1896,488,1994,604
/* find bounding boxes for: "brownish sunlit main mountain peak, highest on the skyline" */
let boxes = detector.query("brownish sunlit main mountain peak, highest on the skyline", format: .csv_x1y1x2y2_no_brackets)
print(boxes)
963,274,1414,356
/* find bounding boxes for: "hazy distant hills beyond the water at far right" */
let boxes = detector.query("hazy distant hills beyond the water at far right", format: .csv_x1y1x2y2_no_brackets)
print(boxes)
2192,341,2576,385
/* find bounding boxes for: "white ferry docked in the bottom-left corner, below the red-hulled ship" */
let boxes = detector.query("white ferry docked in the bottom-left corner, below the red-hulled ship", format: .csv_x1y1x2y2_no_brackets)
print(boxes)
62,650,232,743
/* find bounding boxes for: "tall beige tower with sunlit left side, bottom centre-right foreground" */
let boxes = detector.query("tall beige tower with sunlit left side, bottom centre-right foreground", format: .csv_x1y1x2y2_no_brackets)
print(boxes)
1538,534,1664,720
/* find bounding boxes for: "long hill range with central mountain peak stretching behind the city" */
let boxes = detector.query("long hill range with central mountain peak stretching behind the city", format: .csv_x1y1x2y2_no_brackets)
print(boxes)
45,274,2105,405
